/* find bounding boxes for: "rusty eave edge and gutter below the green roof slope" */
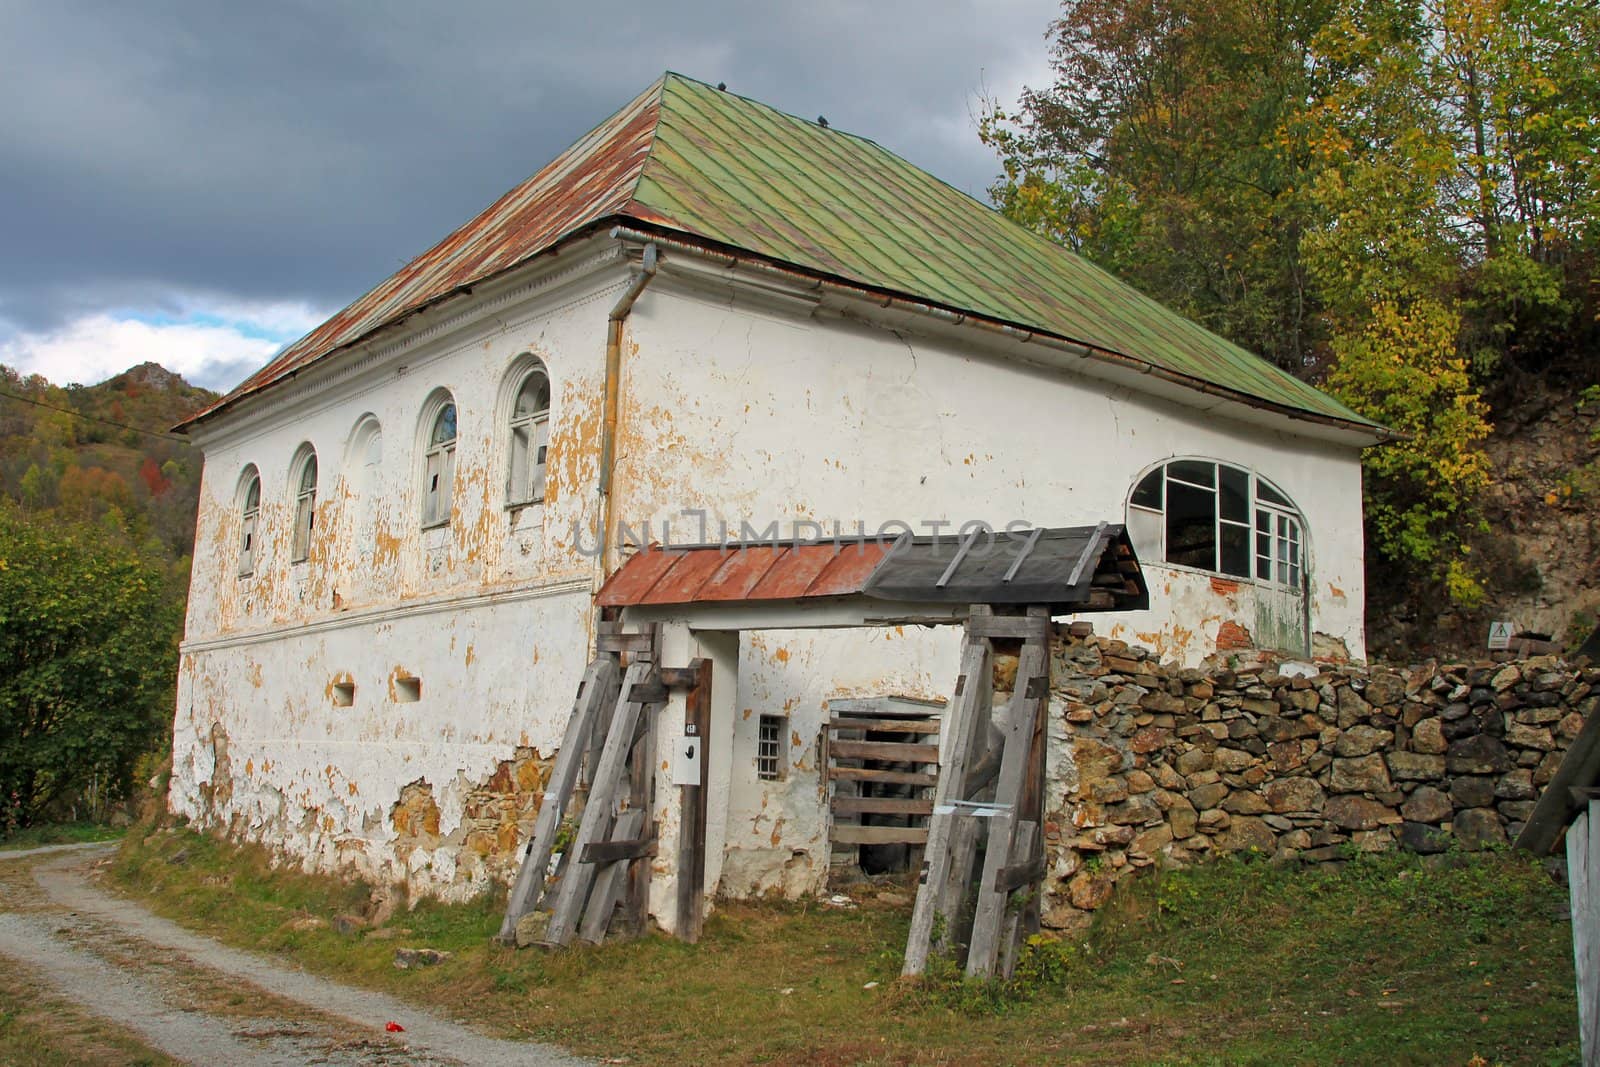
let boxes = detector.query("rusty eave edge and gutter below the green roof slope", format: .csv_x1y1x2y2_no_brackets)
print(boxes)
611,216,1405,445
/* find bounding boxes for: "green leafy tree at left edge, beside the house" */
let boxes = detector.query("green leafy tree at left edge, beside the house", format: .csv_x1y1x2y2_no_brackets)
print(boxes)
0,502,181,833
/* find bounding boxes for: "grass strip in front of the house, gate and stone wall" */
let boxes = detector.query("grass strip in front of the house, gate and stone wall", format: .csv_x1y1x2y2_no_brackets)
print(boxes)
112,830,1578,1065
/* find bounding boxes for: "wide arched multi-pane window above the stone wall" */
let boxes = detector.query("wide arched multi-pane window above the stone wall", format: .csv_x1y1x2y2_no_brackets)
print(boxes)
1128,459,1306,589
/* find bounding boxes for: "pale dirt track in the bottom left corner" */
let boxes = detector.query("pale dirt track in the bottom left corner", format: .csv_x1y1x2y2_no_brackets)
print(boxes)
0,845,584,1065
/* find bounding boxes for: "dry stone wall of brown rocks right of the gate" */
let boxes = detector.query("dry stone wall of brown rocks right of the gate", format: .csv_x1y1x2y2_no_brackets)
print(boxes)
1045,633,1600,929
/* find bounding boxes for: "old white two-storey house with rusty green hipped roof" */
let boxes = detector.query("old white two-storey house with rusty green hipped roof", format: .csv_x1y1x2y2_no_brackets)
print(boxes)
171,75,1382,897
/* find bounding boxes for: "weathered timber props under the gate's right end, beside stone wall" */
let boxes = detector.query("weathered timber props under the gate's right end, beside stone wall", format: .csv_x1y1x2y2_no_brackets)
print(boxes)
902,606,1050,977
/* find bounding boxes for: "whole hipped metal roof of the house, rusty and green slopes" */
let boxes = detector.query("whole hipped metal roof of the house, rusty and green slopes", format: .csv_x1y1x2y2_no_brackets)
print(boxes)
186,74,1376,429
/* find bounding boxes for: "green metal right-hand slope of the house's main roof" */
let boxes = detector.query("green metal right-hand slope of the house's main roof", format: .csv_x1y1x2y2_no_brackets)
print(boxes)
634,74,1374,426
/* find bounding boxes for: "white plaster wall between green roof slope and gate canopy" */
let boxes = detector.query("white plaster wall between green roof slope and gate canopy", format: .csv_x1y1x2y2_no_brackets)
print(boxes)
604,280,1365,664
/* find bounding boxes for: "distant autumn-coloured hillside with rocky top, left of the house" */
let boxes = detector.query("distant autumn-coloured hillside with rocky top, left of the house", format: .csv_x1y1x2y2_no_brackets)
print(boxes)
0,363,216,565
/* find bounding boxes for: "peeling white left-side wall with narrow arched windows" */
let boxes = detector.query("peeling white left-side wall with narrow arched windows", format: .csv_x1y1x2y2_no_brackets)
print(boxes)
170,246,626,897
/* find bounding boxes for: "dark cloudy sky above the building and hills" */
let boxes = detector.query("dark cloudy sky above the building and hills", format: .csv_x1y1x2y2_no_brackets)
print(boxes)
9,0,1058,389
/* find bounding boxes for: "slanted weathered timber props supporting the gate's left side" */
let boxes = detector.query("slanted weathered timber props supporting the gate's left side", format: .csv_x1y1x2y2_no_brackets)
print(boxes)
496,622,667,947
